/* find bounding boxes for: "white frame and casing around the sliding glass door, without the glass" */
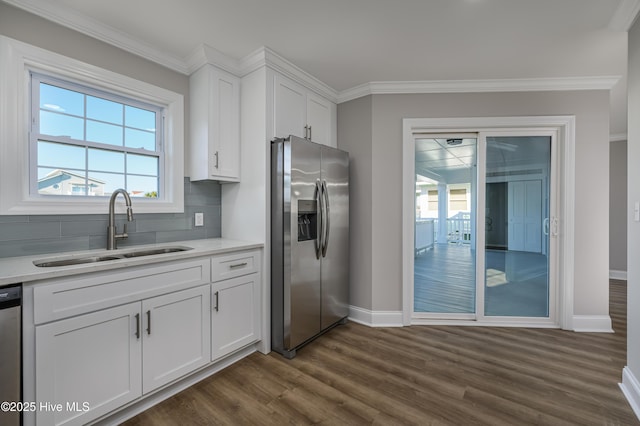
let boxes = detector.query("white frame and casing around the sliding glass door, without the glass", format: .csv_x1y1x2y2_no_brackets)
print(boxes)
402,116,575,330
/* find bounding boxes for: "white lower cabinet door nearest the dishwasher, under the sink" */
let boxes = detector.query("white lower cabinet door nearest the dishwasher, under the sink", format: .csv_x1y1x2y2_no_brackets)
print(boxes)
36,303,142,425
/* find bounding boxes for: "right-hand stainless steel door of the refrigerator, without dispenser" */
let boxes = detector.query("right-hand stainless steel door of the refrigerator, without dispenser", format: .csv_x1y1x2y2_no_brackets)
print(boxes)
321,147,349,330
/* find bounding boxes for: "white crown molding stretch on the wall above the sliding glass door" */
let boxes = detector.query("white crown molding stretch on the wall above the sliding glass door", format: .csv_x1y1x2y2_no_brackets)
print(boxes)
338,76,620,103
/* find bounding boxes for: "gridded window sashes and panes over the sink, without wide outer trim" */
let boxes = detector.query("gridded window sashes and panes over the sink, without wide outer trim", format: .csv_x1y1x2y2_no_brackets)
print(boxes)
30,73,163,198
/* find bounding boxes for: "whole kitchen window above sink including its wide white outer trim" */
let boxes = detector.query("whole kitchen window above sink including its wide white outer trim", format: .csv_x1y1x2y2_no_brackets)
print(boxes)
0,36,184,215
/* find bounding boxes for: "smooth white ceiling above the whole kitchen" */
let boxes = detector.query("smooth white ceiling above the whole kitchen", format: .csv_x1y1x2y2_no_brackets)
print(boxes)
5,0,640,134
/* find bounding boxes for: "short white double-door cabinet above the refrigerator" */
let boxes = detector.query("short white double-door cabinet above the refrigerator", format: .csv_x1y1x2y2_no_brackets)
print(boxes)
273,74,337,147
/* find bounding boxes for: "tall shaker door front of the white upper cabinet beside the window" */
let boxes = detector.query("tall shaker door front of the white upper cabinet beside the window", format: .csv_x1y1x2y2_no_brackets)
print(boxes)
209,67,240,180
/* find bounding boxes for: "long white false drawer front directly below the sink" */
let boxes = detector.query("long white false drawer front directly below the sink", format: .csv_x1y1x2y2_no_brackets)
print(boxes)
33,258,211,324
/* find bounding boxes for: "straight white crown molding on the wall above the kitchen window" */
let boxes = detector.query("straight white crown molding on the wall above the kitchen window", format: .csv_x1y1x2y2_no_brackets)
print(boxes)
2,0,188,74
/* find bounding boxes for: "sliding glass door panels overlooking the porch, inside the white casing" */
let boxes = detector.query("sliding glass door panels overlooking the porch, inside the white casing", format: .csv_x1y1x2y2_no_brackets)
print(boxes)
413,131,556,324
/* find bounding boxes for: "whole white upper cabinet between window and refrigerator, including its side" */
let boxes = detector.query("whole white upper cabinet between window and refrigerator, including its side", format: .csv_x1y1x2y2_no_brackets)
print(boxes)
189,64,240,182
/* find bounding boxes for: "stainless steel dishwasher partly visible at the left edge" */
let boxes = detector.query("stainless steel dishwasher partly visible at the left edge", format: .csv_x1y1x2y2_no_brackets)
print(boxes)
0,284,22,426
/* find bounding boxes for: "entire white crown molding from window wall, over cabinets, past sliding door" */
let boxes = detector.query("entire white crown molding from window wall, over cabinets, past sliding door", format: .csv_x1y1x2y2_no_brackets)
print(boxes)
2,0,624,103
